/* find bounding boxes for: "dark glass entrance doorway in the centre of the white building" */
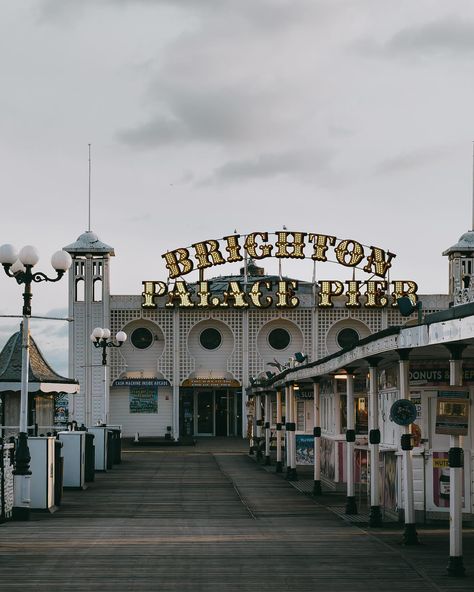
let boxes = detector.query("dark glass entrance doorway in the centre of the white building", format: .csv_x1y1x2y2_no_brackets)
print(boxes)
180,388,242,437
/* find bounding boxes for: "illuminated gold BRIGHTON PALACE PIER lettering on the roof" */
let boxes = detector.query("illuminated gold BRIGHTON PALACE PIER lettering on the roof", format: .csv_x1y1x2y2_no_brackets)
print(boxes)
142,231,418,308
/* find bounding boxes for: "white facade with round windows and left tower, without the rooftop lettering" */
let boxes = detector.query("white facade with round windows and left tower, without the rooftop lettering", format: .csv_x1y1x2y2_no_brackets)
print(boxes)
65,231,449,439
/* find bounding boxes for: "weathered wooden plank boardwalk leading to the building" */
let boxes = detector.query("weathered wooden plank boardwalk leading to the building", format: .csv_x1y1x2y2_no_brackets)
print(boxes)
0,447,474,592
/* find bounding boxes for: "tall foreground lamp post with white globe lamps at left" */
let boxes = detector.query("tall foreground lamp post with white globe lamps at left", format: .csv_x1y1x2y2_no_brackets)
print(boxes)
0,244,72,520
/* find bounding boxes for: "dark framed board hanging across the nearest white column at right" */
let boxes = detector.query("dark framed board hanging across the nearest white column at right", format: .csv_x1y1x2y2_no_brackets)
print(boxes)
435,388,469,436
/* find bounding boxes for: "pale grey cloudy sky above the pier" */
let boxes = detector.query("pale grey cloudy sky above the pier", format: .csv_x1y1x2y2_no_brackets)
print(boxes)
0,0,474,372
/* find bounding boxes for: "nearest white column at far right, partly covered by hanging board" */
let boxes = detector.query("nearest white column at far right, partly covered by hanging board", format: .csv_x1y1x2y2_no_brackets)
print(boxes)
448,351,465,576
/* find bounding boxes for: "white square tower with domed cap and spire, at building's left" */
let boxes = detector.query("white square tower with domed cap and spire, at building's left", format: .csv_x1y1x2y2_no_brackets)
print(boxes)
64,230,115,426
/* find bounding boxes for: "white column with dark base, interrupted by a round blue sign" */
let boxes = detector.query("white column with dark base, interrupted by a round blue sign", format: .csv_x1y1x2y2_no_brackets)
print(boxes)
399,355,418,545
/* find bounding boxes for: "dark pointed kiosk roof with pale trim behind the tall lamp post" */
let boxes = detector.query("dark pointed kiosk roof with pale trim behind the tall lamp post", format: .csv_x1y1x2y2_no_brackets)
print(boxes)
0,327,79,393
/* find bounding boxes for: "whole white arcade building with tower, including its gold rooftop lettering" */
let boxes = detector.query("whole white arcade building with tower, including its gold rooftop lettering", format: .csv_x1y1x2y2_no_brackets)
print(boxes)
65,231,448,440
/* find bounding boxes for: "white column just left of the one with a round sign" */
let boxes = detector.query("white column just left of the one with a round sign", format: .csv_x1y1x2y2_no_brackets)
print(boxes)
369,360,382,526
